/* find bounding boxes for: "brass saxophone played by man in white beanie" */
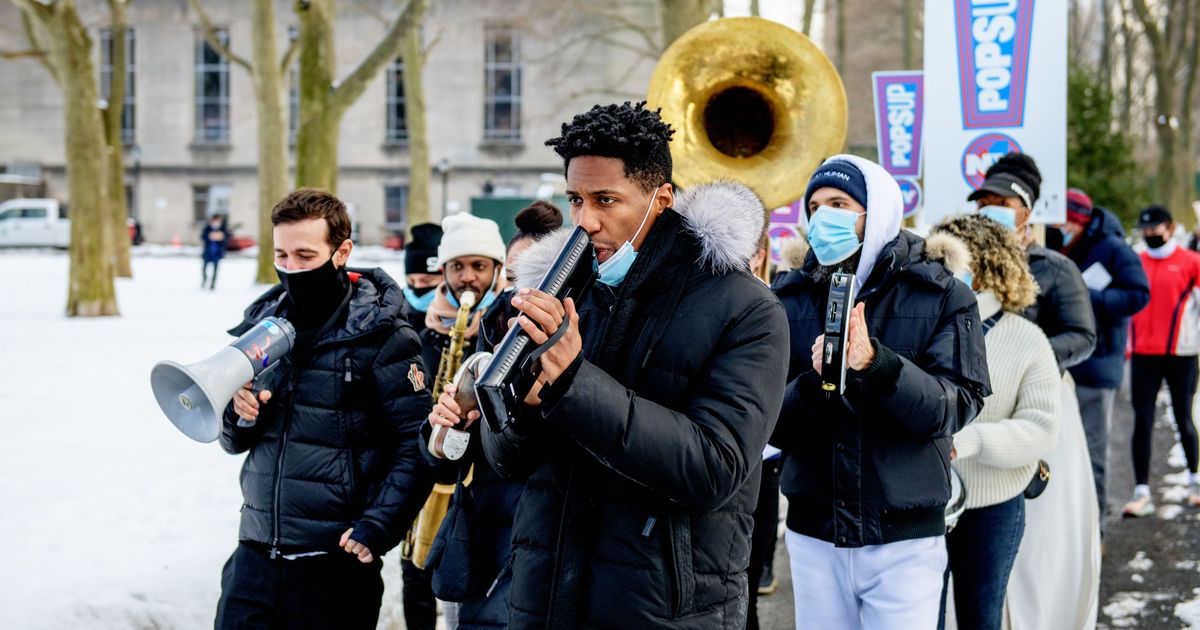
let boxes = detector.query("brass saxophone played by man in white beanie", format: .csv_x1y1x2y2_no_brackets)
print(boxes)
401,290,475,569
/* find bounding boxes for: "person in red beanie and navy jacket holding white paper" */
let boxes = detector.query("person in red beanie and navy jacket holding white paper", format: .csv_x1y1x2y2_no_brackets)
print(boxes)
1046,188,1150,535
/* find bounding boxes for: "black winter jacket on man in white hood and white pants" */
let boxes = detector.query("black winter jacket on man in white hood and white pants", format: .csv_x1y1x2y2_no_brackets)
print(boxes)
772,232,991,547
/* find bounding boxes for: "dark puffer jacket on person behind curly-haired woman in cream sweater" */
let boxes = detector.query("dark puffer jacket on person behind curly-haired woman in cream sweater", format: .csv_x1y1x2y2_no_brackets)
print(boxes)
1021,245,1096,371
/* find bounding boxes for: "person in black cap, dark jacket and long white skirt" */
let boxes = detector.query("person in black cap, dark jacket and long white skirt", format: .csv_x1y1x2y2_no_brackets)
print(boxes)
967,154,1100,630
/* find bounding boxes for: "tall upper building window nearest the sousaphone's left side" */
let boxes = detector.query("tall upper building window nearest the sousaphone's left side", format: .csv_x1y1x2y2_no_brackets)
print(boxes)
484,26,521,143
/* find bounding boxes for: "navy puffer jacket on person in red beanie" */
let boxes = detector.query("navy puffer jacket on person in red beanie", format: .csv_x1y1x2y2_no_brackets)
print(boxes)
1069,208,1150,388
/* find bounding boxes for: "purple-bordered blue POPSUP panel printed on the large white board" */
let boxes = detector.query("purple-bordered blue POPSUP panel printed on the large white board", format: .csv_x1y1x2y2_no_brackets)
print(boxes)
954,0,1033,130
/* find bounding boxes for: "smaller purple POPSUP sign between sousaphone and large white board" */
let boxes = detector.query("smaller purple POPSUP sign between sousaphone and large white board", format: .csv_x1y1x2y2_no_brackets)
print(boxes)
871,72,925,178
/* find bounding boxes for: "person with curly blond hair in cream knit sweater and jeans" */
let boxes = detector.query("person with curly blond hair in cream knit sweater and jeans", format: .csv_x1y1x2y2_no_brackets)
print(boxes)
925,215,1061,630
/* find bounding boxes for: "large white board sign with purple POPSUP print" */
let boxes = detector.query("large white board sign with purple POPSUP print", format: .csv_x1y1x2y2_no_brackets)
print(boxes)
921,0,1068,223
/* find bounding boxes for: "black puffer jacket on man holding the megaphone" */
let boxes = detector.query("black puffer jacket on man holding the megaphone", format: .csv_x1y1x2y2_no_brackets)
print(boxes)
221,269,432,557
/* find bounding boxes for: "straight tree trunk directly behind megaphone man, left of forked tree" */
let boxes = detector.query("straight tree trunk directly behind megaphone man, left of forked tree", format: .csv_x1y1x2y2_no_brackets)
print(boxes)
250,0,288,284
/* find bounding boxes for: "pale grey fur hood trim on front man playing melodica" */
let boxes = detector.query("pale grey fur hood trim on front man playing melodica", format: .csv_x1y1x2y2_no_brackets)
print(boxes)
512,181,767,288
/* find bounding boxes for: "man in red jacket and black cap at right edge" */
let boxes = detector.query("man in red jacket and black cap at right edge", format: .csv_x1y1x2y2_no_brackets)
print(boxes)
1124,205,1200,516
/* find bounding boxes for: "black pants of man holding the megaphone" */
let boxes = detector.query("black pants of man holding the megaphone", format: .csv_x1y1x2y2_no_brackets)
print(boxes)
214,542,383,630
